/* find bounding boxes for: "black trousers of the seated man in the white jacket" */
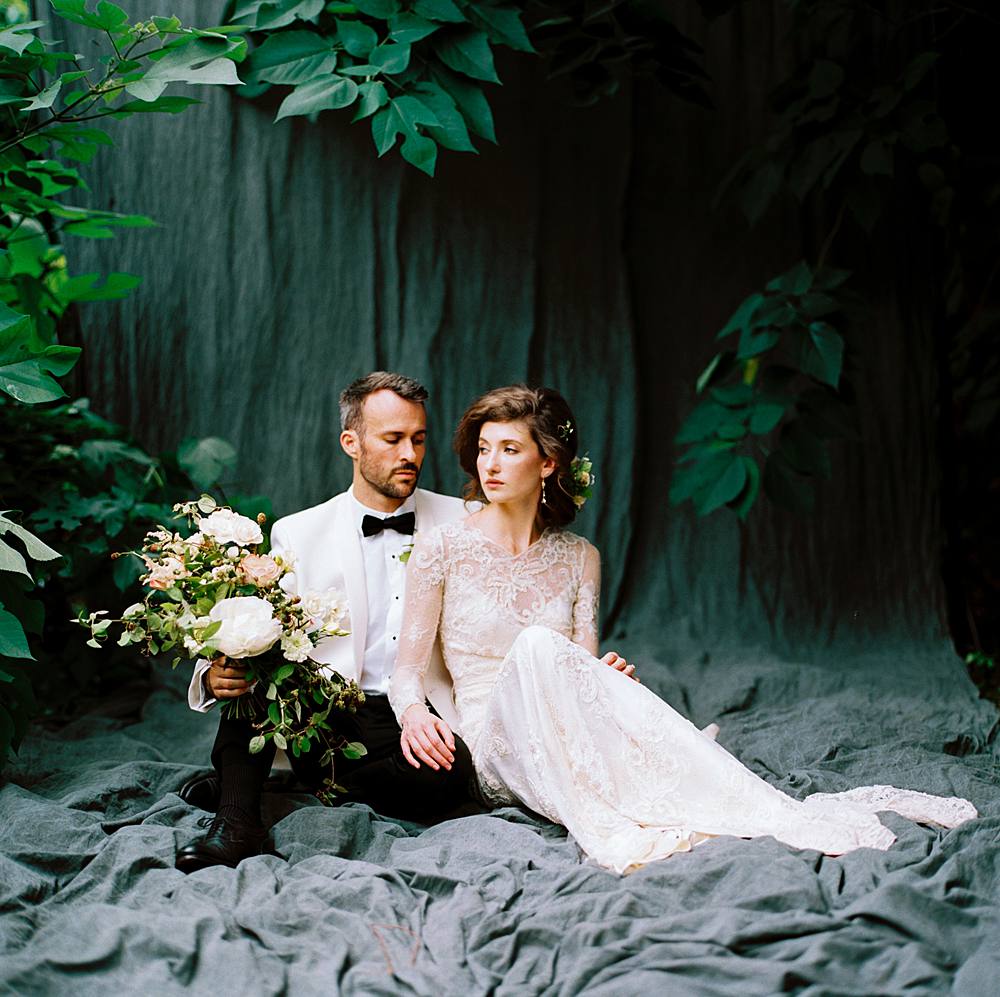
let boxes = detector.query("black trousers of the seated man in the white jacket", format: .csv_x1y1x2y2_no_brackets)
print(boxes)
212,694,475,820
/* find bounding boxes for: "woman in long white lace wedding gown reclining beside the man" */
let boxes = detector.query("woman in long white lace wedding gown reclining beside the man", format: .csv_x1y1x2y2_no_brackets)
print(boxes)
389,386,976,873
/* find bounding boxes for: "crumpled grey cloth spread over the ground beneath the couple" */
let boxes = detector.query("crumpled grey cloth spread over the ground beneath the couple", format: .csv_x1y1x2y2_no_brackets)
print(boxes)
0,644,1000,997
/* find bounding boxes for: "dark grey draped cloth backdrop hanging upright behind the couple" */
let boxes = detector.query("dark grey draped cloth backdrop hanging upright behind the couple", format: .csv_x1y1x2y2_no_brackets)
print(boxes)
64,0,947,657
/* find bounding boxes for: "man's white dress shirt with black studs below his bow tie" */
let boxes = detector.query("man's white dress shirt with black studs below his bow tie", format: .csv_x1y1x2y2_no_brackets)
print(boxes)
351,489,416,696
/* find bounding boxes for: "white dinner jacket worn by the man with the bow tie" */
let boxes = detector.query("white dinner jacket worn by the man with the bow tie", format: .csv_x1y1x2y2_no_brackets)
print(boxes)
188,488,468,729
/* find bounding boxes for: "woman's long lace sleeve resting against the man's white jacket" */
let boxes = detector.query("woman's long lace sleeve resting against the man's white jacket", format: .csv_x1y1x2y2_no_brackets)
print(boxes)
389,530,444,724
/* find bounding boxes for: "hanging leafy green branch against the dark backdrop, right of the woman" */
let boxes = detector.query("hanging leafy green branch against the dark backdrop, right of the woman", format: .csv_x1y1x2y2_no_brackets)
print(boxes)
670,263,857,518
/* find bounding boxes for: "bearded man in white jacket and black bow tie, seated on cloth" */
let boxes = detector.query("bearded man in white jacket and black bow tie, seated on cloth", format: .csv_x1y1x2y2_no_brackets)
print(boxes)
176,371,474,872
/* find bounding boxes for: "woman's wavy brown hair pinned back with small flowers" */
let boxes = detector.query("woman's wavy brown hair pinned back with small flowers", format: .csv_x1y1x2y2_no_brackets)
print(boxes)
453,384,578,528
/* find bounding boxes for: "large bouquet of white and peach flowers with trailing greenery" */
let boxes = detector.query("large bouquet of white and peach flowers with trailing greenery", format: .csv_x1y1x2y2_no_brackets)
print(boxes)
76,495,365,761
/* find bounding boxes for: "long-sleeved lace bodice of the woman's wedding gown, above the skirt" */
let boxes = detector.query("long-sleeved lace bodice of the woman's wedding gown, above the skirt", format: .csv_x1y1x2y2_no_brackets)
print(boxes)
389,520,600,747
